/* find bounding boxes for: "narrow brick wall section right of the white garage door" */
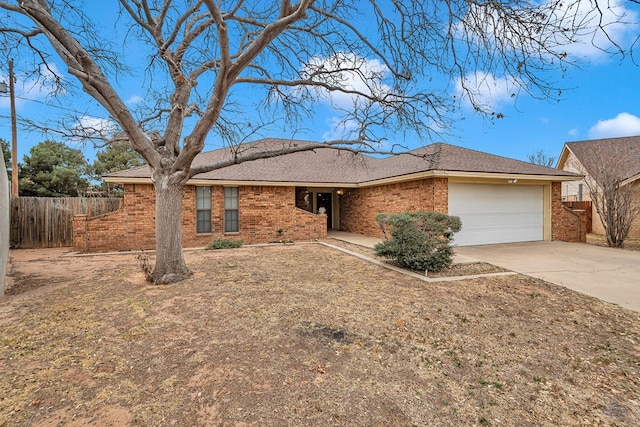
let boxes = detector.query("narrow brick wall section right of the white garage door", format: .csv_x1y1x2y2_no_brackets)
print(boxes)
551,182,587,242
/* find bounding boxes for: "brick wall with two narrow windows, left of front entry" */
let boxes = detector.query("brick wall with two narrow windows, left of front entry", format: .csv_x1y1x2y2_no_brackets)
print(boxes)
73,184,327,252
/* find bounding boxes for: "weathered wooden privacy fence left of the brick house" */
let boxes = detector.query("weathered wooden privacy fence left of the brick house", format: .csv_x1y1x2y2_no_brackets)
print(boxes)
10,197,123,249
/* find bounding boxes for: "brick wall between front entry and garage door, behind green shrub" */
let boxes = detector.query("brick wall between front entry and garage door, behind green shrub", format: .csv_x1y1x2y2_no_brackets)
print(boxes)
340,178,449,237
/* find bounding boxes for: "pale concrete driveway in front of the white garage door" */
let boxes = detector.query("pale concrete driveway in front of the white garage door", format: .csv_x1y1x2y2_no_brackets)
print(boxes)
456,242,640,311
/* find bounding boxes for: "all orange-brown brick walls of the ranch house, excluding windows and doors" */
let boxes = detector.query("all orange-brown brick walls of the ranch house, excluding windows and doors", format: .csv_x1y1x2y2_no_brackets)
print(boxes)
73,178,586,252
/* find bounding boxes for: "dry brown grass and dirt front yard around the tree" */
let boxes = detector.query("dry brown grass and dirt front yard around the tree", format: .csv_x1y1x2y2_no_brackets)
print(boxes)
0,244,640,426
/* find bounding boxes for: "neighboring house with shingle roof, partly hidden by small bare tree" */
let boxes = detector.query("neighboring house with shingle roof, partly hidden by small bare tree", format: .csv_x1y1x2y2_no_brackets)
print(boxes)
557,136,640,238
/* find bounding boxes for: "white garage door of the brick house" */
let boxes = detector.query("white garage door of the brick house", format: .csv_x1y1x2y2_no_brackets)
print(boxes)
449,183,544,246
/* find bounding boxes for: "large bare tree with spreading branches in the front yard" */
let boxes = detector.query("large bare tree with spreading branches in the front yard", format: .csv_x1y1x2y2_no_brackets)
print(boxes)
0,0,622,283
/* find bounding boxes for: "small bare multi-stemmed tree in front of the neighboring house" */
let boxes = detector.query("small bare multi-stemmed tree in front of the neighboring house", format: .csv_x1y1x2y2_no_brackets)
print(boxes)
575,146,640,248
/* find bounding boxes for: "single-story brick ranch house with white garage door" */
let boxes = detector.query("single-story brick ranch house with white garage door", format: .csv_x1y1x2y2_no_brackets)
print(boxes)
73,139,585,252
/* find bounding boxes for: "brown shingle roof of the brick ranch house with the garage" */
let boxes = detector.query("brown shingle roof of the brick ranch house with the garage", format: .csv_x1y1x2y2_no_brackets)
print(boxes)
108,138,575,185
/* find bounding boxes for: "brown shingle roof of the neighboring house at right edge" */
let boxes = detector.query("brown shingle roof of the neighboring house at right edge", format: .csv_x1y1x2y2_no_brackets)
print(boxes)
566,136,640,180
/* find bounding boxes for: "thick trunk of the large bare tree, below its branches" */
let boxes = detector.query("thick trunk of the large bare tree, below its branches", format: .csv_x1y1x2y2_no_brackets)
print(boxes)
151,174,193,284
